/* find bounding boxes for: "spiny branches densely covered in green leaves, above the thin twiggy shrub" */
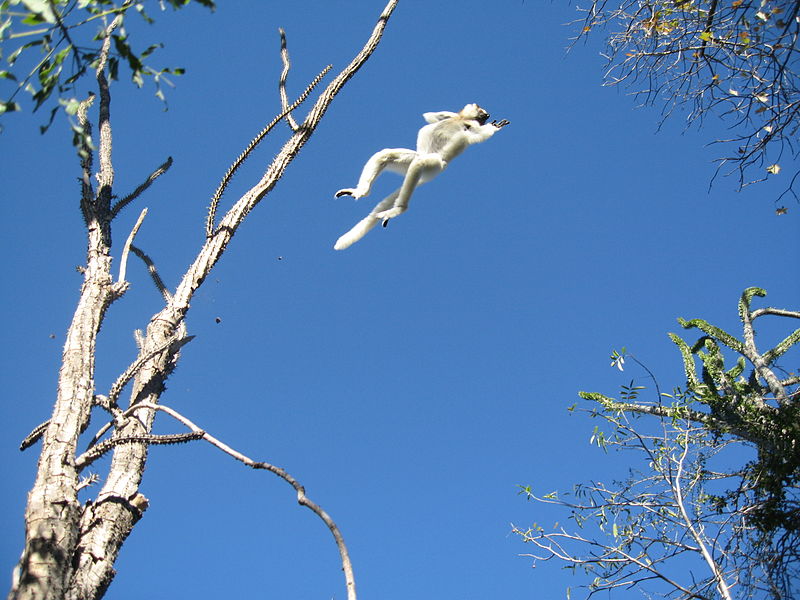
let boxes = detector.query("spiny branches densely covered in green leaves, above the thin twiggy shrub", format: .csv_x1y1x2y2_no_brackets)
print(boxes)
580,287,800,539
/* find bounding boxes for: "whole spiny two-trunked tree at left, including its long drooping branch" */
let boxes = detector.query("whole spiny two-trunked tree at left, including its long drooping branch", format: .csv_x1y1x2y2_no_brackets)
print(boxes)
2,0,397,600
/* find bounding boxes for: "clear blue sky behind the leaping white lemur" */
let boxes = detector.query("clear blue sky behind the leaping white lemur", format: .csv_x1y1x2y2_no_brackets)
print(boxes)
0,0,800,600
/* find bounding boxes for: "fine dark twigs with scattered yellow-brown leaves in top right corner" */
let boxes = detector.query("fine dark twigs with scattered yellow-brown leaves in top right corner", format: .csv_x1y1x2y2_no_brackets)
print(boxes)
580,0,800,206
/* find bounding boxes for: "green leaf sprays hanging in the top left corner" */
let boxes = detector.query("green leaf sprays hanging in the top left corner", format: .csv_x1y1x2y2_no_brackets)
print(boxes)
0,0,214,132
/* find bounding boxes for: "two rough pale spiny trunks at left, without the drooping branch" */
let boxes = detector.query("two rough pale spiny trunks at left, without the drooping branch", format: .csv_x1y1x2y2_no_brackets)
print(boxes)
9,0,397,600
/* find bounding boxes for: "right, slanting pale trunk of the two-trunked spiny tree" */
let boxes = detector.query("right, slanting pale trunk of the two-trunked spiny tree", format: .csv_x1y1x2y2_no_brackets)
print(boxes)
68,5,397,600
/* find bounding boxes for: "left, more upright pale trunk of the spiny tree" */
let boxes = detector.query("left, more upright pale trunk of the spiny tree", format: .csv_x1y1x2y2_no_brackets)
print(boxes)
9,15,122,600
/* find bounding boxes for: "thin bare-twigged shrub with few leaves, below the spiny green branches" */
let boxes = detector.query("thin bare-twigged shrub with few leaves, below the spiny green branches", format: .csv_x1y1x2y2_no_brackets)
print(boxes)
514,413,742,600
